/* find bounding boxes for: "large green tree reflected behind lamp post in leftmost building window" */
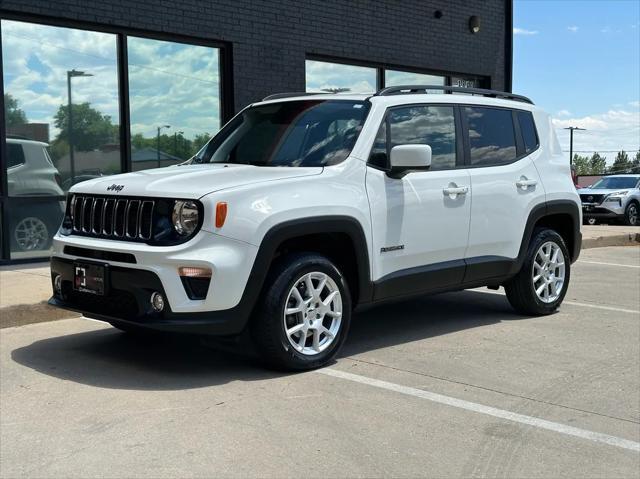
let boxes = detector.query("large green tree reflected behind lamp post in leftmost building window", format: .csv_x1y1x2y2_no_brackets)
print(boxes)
54,103,119,151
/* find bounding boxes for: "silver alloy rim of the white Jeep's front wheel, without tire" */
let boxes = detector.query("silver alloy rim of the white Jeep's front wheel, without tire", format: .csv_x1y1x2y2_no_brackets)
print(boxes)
284,271,342,356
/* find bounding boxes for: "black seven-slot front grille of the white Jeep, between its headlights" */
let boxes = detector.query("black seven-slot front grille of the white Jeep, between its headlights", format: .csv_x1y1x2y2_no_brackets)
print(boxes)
69,195,155,241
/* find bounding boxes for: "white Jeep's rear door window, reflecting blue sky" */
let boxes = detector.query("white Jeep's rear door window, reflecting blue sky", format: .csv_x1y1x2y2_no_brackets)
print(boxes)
465,107,516,166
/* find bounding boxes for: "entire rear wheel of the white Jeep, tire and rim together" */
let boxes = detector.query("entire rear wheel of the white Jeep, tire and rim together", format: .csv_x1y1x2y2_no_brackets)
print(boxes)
505,229,571,316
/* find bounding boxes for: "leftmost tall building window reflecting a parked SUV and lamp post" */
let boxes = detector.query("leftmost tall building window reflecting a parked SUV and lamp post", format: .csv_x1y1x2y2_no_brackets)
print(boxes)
2,20,121,258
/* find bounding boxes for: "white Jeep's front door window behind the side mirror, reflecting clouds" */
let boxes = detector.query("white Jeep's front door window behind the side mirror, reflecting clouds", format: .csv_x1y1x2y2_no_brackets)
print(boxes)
389,106,456,171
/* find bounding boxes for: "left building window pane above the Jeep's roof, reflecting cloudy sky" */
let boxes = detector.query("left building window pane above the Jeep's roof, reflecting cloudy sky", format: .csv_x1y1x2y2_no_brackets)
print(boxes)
305,60,377,93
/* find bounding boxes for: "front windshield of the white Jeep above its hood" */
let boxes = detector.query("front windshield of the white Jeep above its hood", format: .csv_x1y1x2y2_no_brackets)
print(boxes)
192,100,369,166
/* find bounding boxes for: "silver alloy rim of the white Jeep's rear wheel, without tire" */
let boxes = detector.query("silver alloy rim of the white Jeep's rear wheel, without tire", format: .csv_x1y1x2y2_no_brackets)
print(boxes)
532,241,565,303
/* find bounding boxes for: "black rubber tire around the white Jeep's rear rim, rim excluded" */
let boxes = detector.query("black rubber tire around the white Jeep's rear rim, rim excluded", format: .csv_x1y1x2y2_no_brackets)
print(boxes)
504,229,571,316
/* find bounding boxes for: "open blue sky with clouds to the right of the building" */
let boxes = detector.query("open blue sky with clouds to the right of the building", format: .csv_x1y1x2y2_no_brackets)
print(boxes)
513,0,640,161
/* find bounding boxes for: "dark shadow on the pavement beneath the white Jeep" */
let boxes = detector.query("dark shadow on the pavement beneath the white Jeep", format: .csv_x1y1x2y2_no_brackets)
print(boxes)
11,291,519,390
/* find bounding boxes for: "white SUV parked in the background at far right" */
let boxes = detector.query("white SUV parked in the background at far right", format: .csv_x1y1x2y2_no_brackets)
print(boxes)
578,175,640,226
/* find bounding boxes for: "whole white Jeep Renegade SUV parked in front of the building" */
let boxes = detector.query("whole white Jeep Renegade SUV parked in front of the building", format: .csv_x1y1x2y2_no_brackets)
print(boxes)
50,86,582,369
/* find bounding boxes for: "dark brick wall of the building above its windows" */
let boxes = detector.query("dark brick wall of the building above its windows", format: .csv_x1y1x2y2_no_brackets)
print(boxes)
0,0,511,114
